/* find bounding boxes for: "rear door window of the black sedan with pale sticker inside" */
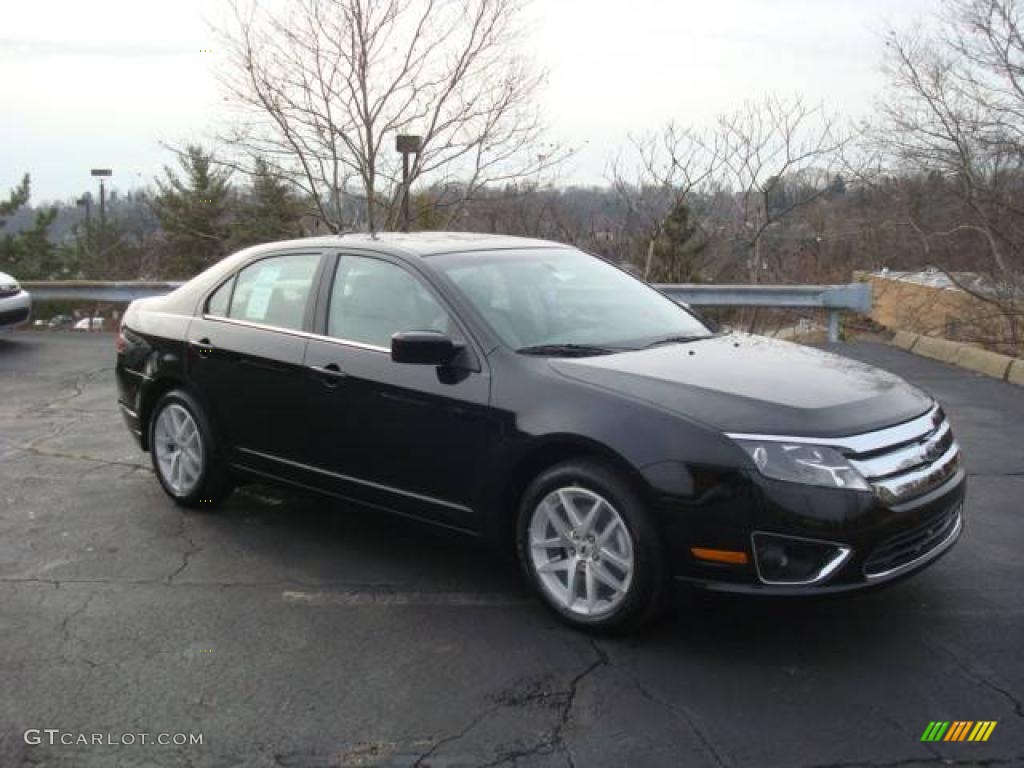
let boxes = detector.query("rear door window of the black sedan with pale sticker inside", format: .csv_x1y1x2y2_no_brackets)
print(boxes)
227,253,319,331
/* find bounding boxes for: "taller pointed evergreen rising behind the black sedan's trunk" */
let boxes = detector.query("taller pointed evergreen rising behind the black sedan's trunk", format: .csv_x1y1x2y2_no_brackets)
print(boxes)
152,144,231,278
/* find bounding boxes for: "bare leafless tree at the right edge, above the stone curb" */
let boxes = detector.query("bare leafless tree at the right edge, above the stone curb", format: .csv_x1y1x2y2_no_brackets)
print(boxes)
878,0,1024,350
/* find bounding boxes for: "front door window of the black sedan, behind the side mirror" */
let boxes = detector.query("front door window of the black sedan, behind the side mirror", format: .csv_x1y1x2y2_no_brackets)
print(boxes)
327,256,455,349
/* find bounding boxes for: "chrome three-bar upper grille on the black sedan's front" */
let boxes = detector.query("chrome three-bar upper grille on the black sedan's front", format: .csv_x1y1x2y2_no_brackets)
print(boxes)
840,406,961,504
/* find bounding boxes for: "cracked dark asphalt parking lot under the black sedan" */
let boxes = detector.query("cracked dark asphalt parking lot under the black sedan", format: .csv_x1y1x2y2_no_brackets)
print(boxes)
0,332,1024,768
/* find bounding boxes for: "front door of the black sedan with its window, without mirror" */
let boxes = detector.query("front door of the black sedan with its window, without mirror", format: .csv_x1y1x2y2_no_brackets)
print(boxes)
306,250,493,528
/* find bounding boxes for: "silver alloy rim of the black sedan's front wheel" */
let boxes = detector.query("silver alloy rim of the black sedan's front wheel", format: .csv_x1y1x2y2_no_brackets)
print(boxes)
527,485,634,618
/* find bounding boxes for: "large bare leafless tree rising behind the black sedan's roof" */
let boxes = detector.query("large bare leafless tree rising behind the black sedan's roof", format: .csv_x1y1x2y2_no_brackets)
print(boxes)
223,0,566,231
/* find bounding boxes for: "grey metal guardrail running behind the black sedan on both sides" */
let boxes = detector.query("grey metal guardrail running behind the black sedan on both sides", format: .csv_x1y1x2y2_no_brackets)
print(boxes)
22,281,871,342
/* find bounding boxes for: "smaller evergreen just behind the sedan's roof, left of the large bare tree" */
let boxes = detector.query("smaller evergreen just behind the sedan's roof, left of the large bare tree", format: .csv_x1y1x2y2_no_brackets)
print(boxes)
231,158,303,248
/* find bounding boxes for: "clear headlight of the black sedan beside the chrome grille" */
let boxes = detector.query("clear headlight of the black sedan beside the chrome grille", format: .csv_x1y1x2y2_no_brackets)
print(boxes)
736,440,871,490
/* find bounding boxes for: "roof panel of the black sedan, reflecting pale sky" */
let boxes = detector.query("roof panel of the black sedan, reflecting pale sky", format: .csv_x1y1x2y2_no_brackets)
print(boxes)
236,231,566,257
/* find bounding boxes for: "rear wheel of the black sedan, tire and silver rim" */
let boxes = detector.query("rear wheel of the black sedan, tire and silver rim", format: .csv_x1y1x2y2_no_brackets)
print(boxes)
148,389,233,509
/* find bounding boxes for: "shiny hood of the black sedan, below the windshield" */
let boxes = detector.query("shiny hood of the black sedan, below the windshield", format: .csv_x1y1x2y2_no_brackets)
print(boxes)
549,333,932,437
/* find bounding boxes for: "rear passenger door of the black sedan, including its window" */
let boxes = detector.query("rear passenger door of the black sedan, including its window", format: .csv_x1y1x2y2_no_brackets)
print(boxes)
187,252,321,476
